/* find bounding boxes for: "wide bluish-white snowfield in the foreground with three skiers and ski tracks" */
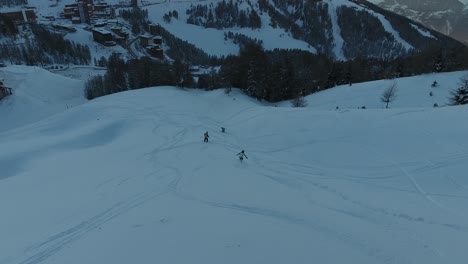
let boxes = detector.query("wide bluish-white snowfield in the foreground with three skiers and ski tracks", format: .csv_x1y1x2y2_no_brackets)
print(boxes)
0,66,468,264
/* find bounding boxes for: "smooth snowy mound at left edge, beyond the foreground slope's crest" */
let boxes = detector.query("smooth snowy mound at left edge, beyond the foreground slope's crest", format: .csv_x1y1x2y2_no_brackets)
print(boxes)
0,65,86,132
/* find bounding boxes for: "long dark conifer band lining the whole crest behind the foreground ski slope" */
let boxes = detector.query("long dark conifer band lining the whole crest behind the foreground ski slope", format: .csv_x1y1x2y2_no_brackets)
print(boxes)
87,43,468,102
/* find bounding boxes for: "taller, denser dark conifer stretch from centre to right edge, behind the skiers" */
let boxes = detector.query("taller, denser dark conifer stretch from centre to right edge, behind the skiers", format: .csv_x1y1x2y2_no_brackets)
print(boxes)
200,44,468,102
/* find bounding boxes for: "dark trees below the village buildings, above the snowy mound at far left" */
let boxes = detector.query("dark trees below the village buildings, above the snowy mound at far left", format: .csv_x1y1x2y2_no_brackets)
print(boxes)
0,24,91,65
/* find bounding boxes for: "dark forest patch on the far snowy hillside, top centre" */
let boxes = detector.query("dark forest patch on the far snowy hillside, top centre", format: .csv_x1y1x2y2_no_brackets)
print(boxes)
187,0,262,29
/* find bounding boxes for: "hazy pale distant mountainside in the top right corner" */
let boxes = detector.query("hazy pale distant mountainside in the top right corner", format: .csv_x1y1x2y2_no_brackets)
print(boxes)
370,0,468,43
